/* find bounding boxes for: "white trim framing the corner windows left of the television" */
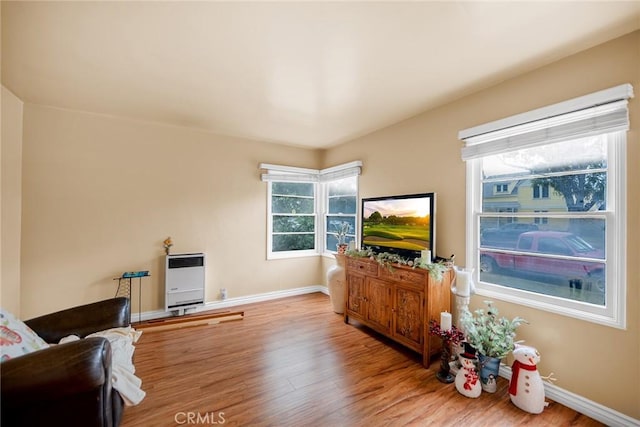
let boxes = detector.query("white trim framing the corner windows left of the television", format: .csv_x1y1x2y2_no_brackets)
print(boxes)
259,160,362,260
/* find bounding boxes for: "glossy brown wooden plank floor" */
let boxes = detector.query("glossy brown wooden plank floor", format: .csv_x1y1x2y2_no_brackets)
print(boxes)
122,293,602,427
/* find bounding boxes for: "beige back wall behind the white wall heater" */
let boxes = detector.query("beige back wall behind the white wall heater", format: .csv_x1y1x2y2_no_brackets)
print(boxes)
22,104,323,318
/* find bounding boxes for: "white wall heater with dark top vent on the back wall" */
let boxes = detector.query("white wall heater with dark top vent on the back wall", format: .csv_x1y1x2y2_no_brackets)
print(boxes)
164,253,206,315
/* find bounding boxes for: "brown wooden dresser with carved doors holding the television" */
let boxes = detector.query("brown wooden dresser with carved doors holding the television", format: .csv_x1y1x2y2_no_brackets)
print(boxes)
344,257,453,367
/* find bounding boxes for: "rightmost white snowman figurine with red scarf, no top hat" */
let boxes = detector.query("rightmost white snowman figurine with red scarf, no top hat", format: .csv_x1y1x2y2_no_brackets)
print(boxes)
509,344,553,414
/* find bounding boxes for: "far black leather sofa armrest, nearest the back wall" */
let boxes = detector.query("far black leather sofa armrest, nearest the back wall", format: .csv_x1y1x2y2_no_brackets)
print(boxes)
25,297,131,343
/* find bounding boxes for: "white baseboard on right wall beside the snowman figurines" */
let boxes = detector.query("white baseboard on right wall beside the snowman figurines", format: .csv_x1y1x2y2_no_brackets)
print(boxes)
500,365,640,427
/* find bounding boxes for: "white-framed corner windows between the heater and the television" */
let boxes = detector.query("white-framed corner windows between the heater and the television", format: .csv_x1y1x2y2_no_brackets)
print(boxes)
260,161,361,259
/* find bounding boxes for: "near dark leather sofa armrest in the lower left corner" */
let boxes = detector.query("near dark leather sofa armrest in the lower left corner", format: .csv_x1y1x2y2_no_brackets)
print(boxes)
0,337,111,406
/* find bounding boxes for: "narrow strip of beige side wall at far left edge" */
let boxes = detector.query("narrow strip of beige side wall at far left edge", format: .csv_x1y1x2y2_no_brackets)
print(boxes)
0,86,23,316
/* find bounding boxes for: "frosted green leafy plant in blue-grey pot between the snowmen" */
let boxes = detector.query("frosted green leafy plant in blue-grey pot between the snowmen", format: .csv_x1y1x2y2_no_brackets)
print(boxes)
460,301,527,392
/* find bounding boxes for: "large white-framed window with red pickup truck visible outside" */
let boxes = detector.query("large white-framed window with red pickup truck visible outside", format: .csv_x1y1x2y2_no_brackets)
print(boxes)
460,85,633,328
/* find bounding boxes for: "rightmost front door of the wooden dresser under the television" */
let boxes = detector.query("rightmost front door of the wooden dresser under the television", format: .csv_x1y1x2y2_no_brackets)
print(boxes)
393,285,424,351
